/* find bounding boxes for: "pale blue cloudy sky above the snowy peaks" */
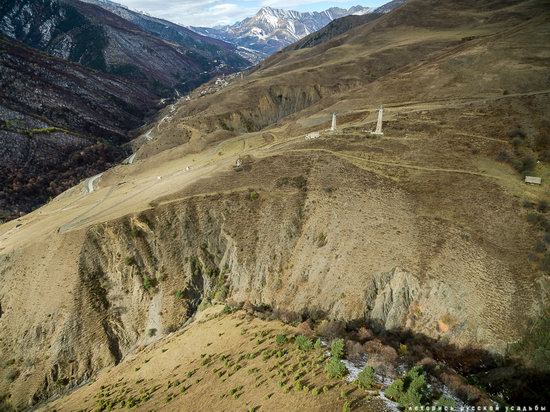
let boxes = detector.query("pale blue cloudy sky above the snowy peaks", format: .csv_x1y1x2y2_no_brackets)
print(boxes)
114,0,389,26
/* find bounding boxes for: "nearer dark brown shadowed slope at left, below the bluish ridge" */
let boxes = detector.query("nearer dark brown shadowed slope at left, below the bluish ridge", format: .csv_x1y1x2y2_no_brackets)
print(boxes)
0,37,158,219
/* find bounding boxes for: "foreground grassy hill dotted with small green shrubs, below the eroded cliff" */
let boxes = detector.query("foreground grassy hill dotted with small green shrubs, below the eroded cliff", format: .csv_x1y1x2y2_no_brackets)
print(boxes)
39,306,492,411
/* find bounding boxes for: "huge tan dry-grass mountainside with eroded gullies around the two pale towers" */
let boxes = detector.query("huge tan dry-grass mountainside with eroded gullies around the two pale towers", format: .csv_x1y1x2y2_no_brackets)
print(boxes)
0,0,550,410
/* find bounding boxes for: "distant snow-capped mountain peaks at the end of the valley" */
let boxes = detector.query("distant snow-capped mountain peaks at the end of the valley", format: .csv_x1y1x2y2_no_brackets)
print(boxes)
190,0,406,63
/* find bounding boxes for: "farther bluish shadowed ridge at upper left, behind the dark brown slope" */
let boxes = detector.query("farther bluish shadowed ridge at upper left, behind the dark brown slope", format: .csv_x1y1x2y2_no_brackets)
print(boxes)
0,0,249,95
